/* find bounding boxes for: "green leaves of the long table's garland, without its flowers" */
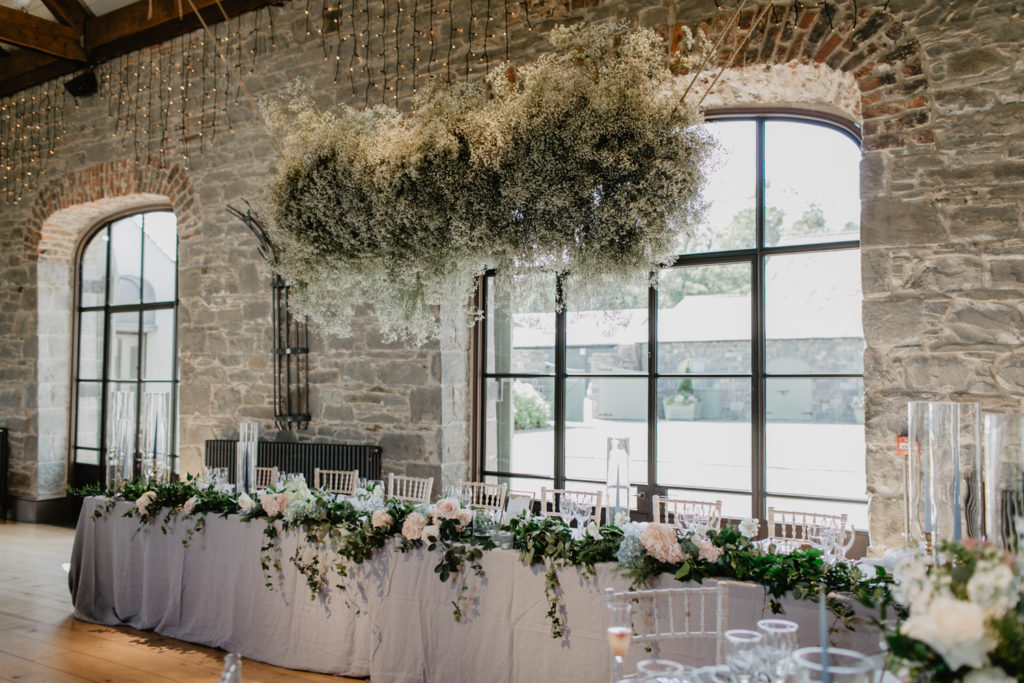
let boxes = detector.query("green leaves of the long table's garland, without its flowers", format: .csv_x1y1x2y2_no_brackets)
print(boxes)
73,478,897,647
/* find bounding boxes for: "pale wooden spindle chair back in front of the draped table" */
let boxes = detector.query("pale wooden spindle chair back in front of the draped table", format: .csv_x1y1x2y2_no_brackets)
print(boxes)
605,581,729,666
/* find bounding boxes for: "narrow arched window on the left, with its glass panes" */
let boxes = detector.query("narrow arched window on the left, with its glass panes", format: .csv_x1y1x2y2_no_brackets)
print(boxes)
73,211,178,484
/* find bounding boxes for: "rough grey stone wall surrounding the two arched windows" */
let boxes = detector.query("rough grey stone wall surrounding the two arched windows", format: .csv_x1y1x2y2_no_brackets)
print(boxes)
0,0,1024,545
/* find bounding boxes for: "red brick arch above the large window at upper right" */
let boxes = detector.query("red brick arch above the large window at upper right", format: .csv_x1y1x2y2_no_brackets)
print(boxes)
672,2,934,152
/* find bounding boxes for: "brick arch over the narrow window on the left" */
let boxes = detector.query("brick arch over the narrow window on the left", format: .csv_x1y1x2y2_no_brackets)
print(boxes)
25,160,200,263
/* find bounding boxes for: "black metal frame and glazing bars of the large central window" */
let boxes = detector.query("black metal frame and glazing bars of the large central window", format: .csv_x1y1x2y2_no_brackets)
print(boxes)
472,114,867,520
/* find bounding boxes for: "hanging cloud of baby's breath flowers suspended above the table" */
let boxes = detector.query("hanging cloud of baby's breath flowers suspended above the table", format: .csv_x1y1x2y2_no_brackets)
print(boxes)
261,24,712,344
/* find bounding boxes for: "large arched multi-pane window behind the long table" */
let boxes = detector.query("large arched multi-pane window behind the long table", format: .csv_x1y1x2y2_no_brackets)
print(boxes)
477,116,867,528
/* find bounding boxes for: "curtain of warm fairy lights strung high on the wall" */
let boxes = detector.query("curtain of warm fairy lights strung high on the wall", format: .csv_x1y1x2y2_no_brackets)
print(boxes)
0,0,856,203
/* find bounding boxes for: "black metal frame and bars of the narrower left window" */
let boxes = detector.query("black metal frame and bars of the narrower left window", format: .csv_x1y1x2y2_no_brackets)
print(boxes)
69,206,180,486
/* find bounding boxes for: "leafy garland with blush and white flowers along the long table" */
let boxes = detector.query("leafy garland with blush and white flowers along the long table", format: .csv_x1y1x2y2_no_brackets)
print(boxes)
71,477,892,638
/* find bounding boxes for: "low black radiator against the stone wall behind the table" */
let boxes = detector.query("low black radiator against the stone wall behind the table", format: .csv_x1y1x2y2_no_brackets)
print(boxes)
204,439,381,484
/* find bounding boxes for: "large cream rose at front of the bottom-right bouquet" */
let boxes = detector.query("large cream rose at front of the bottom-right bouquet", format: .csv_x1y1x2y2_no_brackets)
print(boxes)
900,596,996,671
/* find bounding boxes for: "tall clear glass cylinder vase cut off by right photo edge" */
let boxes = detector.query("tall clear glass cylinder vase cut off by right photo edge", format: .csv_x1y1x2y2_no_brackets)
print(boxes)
984,413,1024,553
